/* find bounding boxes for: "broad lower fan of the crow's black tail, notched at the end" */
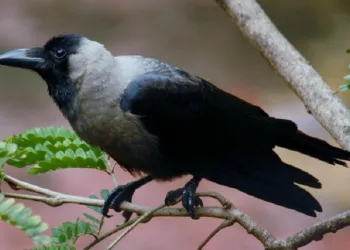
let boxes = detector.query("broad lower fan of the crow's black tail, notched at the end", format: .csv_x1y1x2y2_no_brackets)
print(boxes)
204,151,322,217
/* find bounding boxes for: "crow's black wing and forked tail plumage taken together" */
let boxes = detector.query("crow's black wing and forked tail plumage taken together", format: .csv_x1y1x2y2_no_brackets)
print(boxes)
121,69,350,216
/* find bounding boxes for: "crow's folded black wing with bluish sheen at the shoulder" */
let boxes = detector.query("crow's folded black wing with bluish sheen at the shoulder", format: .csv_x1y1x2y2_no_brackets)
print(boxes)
121,70,297,156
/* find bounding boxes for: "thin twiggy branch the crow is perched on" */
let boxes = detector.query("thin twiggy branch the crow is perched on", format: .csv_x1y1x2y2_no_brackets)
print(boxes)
4,175,350,250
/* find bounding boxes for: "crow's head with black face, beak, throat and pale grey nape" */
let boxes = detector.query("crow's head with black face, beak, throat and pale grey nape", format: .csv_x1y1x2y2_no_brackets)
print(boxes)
0,34,114,117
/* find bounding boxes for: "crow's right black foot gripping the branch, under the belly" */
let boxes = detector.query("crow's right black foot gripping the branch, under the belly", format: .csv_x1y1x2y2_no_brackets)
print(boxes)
165,177,203,219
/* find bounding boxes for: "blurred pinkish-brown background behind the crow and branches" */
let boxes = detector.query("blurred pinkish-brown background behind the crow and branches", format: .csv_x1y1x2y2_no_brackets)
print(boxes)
0,0,350,250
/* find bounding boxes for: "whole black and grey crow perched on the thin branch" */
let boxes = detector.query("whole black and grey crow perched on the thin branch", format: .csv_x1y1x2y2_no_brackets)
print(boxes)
0,33,350,221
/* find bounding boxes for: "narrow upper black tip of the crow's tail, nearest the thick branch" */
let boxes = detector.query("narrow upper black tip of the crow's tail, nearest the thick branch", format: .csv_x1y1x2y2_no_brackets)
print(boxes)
277,131,350,167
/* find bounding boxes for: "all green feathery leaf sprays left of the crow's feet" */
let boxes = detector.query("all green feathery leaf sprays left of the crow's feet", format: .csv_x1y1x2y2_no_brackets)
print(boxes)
0,127,114,250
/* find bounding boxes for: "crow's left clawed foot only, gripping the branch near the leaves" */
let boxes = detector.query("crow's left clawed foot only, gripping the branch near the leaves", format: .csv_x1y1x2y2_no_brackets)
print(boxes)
101,184,136,222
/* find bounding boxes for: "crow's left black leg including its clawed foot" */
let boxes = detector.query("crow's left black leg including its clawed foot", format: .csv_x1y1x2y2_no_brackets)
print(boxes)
101,175,153,222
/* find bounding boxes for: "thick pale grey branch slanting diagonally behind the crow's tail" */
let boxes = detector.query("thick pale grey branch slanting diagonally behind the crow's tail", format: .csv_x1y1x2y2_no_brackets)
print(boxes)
216,0,350,150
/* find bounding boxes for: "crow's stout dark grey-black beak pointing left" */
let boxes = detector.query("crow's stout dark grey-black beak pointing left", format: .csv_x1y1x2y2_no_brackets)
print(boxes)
0,48,45,70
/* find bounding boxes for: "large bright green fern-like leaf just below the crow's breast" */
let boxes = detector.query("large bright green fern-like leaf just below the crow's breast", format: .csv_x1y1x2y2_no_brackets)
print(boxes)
0,127,108,175
